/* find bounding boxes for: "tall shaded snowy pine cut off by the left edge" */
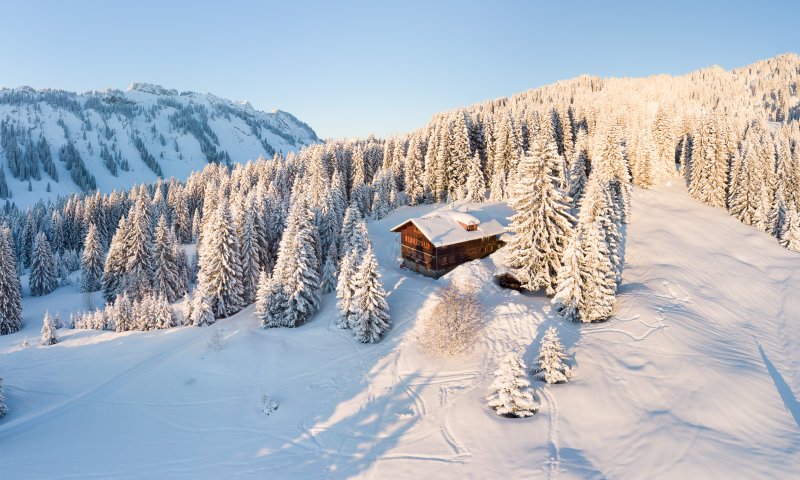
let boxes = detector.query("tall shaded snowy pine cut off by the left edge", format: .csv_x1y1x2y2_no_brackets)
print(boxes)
0,225,22,335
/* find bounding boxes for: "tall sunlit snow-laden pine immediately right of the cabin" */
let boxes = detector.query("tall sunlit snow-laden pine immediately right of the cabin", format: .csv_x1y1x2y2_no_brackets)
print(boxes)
508,142,574,295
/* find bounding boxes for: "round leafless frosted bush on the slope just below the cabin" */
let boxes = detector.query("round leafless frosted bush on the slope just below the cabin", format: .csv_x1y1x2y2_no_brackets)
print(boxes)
420,283,485,356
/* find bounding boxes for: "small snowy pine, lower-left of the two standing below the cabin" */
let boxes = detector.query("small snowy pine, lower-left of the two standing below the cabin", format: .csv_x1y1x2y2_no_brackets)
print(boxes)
488,351,539,417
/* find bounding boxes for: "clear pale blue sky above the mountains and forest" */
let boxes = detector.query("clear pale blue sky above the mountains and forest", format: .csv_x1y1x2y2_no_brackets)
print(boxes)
0,0,800,137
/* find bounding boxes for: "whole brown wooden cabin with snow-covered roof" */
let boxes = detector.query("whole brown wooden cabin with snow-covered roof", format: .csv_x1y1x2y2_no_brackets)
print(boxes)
391,209,505,278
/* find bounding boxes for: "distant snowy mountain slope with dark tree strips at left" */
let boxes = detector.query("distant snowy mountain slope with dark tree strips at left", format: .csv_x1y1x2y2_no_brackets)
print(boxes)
0,83,319,206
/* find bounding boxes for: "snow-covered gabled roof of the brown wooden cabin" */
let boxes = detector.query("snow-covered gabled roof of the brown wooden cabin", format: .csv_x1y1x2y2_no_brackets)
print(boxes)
391,208,506,247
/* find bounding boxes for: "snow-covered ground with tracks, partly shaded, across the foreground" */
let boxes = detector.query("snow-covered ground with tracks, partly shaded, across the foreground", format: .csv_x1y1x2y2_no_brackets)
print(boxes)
0,186,800,479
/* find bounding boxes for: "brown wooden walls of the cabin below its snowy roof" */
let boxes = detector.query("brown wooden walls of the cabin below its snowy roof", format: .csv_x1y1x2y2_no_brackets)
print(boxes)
400,222,502,278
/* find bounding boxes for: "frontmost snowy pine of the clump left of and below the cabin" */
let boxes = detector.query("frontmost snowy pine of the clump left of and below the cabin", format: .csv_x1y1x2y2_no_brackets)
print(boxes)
350,245,390,343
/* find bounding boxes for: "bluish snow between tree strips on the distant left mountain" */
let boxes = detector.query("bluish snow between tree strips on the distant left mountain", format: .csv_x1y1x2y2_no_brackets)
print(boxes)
0,83,320,208
